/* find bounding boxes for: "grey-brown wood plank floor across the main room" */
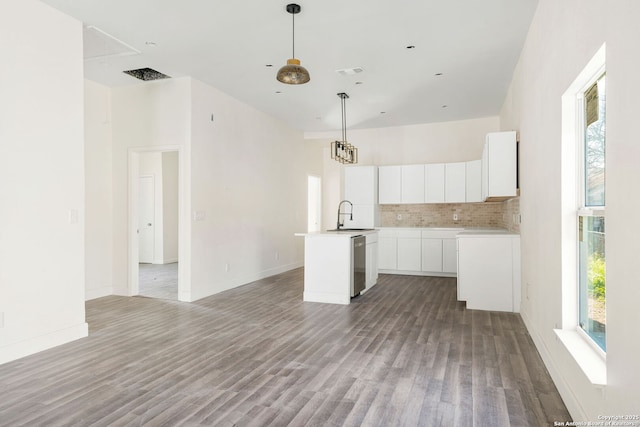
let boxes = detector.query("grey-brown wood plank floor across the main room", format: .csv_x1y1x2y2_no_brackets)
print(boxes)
0,269,570,427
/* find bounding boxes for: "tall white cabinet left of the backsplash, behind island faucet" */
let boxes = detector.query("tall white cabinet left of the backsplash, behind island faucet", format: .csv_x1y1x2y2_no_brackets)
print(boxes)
341,166,380,228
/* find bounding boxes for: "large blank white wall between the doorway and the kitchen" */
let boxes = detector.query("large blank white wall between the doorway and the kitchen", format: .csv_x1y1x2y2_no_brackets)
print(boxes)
188,80,308,299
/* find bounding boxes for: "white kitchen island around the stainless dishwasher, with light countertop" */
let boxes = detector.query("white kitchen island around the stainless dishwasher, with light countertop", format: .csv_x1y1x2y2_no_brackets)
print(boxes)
296,229,378,304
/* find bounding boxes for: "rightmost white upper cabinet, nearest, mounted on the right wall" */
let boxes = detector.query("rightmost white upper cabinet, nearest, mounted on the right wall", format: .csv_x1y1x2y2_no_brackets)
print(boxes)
482,131,517,201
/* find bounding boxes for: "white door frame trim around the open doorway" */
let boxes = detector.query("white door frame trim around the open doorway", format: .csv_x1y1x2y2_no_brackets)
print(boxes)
127,145,191,302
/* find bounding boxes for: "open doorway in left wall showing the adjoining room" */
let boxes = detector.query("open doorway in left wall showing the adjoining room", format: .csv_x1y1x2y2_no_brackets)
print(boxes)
128,147,190,301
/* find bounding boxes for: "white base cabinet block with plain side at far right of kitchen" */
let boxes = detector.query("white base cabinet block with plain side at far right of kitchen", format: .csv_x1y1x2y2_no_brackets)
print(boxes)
458,233,520,312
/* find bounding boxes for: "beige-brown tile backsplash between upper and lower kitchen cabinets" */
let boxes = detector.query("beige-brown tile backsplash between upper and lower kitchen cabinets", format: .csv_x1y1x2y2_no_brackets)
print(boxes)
380,197,520,232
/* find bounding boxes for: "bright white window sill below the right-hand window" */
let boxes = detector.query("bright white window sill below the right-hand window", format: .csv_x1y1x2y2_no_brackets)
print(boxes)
553,329,607,387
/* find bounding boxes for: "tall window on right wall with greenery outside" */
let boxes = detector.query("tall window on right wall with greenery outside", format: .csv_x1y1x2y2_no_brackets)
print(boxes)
577,73,607,351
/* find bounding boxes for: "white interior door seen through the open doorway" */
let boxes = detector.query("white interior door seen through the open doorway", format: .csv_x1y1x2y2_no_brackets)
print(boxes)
138,176,155,263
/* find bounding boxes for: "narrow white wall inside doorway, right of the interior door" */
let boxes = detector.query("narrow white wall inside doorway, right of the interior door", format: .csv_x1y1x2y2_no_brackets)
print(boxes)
162,151,179,264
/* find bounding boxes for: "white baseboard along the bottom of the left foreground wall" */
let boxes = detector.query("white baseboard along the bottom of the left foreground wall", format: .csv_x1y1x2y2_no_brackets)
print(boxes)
0,322,89,365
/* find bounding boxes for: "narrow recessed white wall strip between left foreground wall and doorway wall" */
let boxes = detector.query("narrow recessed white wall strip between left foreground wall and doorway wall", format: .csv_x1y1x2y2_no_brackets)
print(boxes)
84,80,113,300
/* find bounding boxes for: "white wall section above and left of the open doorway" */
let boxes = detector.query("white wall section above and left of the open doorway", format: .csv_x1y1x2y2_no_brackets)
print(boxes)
112,78,191,299
